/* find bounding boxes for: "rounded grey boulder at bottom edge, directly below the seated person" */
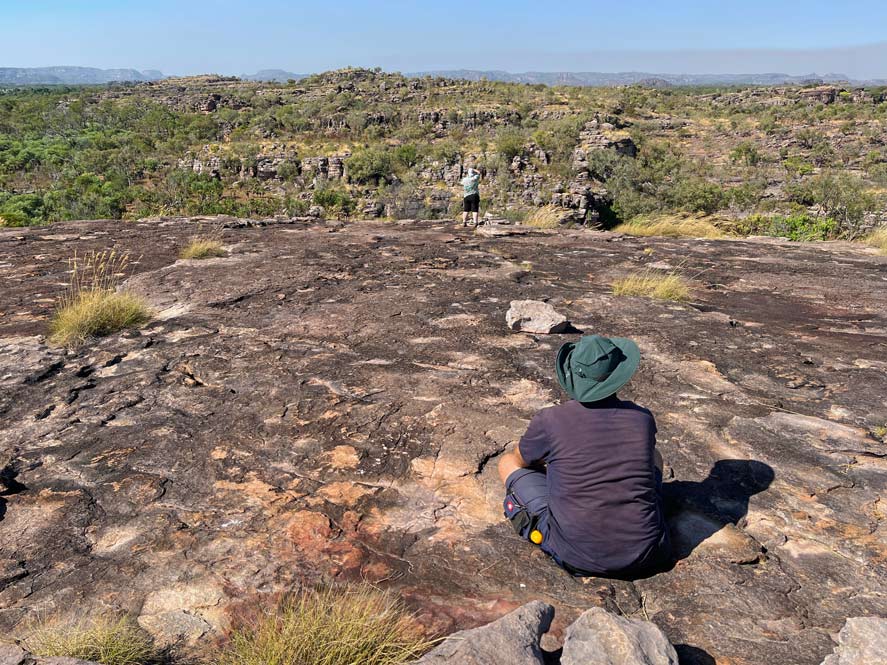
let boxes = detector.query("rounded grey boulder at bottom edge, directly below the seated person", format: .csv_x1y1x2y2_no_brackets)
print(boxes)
560,607,680,665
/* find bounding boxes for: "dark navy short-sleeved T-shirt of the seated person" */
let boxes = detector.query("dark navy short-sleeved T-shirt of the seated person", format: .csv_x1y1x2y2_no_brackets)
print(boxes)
519,396,668,574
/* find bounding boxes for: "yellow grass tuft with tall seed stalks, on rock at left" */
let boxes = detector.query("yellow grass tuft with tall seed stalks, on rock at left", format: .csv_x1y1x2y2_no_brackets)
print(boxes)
49,250,150,347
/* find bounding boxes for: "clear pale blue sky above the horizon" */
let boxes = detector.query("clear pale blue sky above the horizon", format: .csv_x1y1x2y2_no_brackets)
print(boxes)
0,0,887,78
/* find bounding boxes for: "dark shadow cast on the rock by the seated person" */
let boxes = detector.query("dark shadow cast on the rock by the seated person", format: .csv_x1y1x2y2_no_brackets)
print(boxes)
662,459,776,559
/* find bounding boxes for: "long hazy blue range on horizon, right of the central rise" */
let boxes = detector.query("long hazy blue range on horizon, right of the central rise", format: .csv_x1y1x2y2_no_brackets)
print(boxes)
407,69,860,87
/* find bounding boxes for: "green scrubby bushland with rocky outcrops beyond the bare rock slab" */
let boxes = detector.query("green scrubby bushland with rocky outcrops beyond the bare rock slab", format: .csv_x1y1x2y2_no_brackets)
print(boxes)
0,70,887,238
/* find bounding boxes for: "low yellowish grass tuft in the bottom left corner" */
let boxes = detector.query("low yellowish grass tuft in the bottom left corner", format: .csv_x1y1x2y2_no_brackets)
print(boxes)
22,616,164,665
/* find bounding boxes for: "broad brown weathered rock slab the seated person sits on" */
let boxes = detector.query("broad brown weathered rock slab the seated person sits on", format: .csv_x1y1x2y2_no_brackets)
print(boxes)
0,219,887,665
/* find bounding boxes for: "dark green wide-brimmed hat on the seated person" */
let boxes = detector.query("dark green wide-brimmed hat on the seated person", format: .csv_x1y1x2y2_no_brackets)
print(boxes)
555,335,641,402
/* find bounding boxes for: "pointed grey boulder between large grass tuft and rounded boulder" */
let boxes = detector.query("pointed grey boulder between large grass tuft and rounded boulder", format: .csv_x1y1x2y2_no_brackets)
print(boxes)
417,600,556,665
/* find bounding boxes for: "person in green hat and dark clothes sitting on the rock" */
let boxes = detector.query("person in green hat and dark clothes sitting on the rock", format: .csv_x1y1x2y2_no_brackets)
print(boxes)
499,335,671,577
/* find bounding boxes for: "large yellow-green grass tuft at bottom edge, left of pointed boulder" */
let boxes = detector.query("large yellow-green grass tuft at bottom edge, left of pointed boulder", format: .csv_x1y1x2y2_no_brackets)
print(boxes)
213,586,431,665
